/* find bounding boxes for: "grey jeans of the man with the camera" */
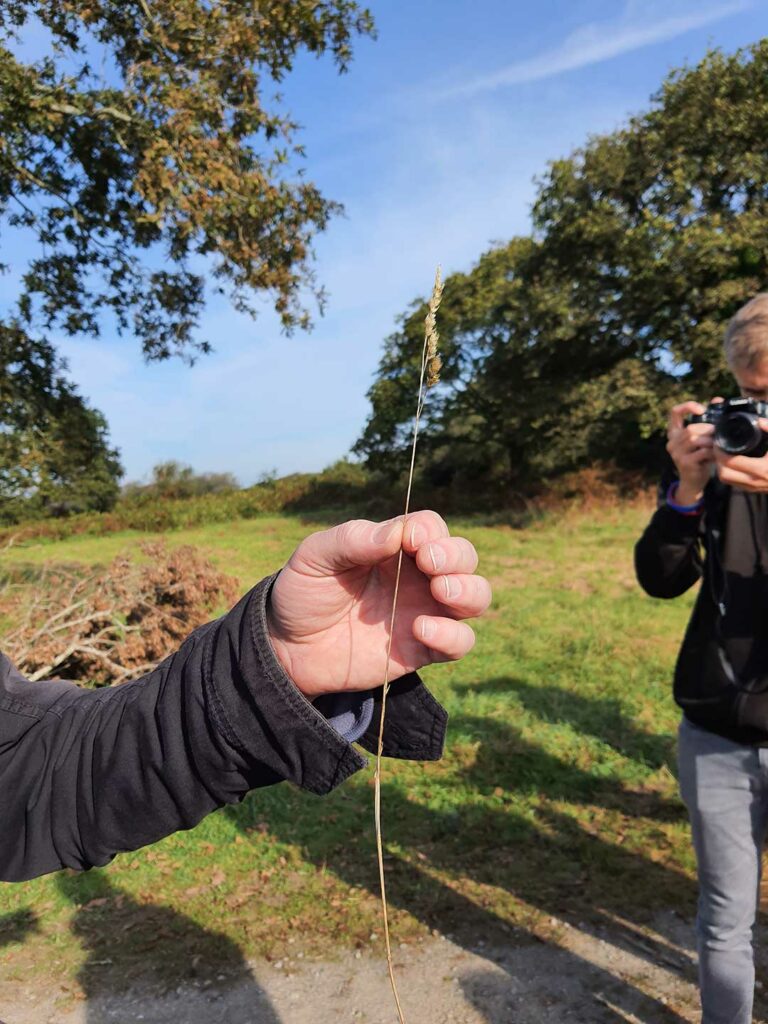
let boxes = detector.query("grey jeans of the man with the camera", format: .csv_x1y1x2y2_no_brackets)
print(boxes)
678,719,768,1024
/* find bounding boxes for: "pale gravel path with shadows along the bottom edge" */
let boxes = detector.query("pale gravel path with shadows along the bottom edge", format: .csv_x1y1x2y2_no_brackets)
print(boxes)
0,914,733,1024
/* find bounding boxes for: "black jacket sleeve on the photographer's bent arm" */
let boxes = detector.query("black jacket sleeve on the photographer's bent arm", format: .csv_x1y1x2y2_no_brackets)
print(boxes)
635,476,702,598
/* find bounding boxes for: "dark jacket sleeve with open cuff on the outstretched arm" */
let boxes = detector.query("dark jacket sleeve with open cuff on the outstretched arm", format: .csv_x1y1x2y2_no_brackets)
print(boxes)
0,578,447,881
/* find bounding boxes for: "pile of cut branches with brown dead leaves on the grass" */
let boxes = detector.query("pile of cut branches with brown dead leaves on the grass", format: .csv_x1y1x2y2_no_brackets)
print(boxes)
0,542,239,686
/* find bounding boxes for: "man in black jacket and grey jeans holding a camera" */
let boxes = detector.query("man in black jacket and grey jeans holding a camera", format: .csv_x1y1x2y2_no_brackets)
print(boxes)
635,293,768,1024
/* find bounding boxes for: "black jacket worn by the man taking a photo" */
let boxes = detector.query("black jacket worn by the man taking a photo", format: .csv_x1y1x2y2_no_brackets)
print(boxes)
635,466,768,745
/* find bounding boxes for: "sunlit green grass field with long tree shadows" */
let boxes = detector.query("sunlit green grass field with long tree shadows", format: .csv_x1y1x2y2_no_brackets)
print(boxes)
0,507,694,991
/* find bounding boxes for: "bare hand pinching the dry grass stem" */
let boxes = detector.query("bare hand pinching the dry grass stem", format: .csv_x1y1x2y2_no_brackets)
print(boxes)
268,512,490,698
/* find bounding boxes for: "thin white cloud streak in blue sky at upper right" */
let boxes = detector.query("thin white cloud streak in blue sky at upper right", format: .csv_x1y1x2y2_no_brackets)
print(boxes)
436,0,753,99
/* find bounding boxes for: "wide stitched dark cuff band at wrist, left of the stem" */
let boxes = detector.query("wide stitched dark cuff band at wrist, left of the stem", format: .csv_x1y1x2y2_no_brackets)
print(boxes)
206,573,367,794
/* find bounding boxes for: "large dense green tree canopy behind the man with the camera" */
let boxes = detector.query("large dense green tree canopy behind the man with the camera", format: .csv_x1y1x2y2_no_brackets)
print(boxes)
356,41,768,492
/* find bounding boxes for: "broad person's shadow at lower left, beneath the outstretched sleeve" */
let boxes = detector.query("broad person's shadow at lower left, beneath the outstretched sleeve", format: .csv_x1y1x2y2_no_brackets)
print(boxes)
56,869,280,1024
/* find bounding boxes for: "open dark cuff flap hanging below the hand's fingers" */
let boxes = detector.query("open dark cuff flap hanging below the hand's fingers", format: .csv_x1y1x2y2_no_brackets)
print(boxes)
358,672,447,761
